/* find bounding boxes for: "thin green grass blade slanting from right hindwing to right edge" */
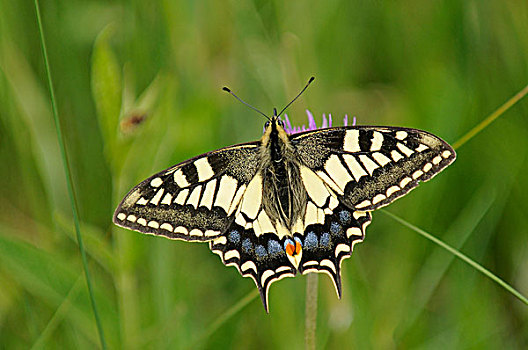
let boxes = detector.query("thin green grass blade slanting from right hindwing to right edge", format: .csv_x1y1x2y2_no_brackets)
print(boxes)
380,209,528,305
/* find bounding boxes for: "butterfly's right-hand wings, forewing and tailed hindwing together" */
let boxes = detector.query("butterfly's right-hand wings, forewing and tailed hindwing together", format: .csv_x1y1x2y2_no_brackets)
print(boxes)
282,126,455,297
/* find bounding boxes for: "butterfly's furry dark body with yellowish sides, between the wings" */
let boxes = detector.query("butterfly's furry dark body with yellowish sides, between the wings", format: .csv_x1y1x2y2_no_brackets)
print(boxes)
260,118,306,232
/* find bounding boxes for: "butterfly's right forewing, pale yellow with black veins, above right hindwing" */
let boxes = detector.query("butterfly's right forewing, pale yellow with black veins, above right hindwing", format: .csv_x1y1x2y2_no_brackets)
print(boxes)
291,126,456,211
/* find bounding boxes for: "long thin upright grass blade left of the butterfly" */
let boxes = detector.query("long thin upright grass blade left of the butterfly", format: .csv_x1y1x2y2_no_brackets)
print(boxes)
35,0,106,349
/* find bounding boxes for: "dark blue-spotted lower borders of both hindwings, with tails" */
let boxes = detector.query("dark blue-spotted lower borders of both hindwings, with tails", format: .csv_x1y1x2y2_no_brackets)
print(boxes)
209,194,371,312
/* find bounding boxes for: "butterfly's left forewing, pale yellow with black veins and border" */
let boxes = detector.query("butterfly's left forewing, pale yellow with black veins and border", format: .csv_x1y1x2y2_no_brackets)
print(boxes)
113,142,260,241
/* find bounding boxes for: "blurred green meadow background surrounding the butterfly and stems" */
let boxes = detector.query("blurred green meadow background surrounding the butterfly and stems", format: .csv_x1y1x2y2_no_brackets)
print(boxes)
0,0,528,349
